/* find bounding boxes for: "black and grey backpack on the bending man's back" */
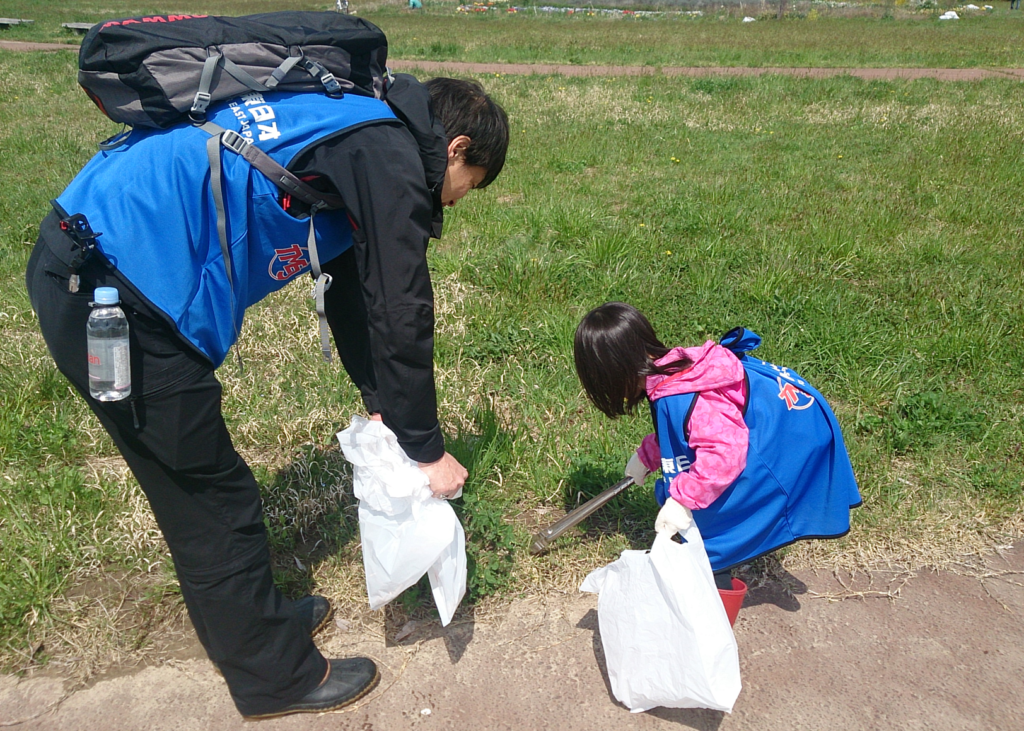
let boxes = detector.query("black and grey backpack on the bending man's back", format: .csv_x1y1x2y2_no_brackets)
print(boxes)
78,11,387,128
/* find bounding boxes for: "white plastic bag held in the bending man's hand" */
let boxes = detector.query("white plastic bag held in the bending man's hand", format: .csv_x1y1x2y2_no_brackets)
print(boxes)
338,416,466,625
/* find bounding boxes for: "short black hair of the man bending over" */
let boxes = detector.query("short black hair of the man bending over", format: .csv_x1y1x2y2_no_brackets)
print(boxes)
426,77,509,188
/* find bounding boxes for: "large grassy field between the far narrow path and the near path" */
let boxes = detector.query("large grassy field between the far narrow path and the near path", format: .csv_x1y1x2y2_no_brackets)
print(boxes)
0,3,1024,668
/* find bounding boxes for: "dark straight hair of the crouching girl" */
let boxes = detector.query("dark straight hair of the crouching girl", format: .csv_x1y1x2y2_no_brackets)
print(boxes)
572,302,692,419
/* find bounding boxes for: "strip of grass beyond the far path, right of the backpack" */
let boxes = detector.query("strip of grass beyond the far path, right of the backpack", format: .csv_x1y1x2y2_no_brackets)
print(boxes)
380,10,1024,68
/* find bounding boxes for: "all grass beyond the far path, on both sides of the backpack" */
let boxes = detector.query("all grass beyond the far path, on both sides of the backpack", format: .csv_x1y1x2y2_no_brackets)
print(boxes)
0,0,1024,68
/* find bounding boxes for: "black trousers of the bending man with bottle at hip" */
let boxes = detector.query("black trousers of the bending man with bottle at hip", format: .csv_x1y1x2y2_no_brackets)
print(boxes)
26,214,327,716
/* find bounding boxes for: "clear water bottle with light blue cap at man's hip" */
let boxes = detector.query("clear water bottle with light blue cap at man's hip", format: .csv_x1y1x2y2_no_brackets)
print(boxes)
85,287,131,401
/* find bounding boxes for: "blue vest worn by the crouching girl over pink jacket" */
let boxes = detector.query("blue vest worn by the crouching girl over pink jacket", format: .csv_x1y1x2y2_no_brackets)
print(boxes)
651,330,860,571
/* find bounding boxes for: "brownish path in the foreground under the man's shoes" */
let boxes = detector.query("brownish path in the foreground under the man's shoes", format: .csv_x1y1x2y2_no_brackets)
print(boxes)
0,544,1024,731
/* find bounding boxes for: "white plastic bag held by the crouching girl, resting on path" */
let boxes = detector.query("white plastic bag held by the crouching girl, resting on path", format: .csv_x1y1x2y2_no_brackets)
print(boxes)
580,525,740,713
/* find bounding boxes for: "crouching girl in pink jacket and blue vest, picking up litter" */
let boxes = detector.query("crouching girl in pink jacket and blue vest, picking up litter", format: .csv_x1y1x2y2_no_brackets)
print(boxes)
573,302,860,590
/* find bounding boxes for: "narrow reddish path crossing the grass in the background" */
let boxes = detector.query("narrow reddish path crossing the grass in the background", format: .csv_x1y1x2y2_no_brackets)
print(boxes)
0,41,1024,81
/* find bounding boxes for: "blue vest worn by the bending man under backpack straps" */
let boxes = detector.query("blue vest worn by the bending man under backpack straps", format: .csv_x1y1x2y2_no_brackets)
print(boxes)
57,92,395,367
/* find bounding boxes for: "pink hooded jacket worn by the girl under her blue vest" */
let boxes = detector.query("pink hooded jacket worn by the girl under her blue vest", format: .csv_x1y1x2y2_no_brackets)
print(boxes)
637,340,750,510
